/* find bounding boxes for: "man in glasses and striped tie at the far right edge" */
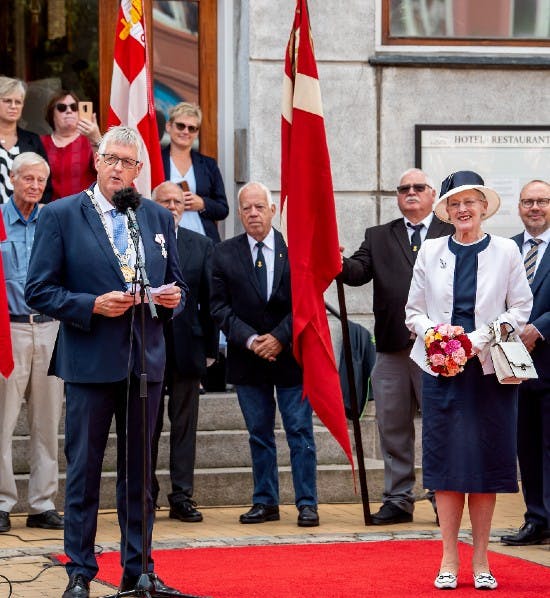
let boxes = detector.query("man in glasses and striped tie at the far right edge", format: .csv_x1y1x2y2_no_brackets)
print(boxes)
501,180,550,546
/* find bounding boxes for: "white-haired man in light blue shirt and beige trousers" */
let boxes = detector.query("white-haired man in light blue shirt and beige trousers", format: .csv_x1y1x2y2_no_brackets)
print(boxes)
0,152,63,532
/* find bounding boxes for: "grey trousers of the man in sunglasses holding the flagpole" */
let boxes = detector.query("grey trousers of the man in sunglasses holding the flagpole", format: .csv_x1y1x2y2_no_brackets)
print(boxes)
372,348,422,513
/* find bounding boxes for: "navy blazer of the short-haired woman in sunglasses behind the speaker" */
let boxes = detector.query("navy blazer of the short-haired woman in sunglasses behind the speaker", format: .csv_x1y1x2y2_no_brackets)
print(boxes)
162,145,229,243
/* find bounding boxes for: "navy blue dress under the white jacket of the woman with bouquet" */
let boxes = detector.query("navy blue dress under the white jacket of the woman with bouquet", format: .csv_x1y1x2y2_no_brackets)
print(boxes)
422,235,518,493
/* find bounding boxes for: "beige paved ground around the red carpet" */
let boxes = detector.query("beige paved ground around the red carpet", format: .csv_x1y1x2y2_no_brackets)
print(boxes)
0,494,550,598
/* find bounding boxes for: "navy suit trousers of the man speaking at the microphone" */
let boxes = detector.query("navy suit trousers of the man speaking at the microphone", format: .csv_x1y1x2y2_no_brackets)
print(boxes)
65,375,162,579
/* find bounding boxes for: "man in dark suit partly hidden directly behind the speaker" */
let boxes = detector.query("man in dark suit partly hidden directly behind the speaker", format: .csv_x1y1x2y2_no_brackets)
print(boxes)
151,181,218,523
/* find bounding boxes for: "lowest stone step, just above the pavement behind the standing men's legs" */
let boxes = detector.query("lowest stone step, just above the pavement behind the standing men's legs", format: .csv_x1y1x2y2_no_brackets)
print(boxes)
13,459,423,513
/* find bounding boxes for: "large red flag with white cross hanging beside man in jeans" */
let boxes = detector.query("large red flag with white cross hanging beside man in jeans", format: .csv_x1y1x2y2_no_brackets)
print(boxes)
281,0,352,462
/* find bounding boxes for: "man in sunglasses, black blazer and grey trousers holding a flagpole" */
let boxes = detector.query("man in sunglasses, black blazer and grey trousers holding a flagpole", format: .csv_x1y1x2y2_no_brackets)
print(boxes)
340,168,454,525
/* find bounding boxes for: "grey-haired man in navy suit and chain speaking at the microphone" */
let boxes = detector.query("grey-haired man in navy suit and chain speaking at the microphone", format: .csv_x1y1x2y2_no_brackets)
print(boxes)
25,127,185,598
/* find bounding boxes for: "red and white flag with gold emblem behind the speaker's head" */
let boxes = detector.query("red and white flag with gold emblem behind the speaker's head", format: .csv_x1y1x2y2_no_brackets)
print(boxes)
107,0,164,197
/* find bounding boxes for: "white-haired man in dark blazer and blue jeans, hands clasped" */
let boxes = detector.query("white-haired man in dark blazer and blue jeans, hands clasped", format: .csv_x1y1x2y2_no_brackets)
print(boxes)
210,183,319,527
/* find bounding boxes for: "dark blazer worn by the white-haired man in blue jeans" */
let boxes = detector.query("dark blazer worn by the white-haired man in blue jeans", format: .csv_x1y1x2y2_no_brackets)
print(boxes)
210,231,302,387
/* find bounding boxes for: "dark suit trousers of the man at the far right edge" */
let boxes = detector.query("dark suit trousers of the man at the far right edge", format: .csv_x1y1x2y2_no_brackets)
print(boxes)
518,380,550,529
